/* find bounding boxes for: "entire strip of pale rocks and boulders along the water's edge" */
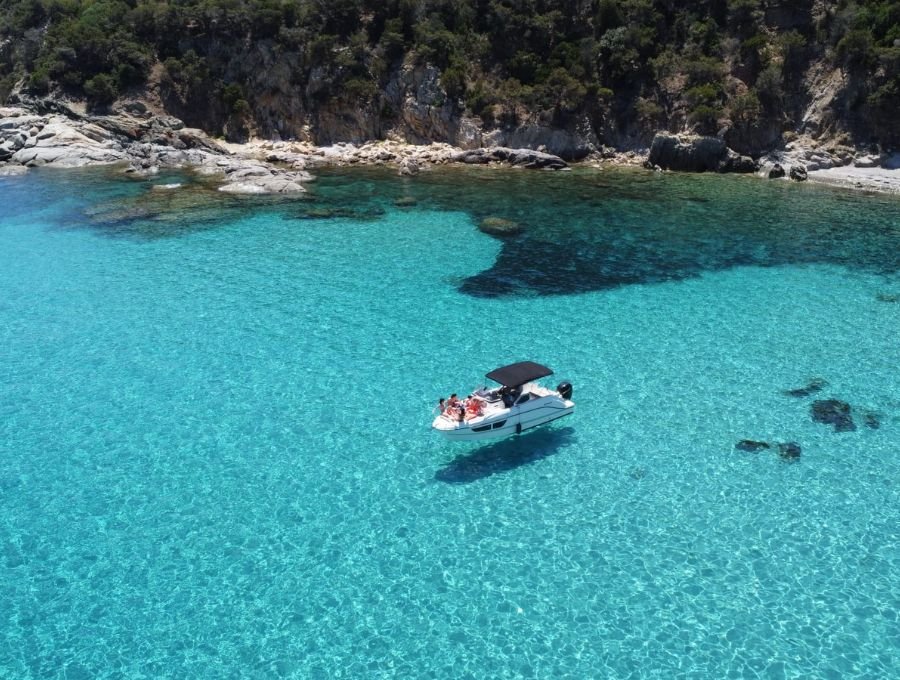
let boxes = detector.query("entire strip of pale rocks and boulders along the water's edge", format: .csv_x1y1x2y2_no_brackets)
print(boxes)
0,100,900,195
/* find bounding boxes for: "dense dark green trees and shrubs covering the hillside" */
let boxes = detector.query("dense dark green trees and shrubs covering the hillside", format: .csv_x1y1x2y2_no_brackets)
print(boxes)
0,0,900,146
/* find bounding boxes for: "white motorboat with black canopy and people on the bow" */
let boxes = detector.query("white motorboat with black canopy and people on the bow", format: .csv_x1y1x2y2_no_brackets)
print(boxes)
431,361,575,441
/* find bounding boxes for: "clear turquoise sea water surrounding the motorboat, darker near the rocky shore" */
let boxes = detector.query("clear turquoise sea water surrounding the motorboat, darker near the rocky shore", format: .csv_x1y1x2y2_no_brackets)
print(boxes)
0,163,900,678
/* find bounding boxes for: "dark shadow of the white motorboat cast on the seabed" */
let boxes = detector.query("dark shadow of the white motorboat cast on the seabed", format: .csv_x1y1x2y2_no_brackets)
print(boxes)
434,427,575,484
